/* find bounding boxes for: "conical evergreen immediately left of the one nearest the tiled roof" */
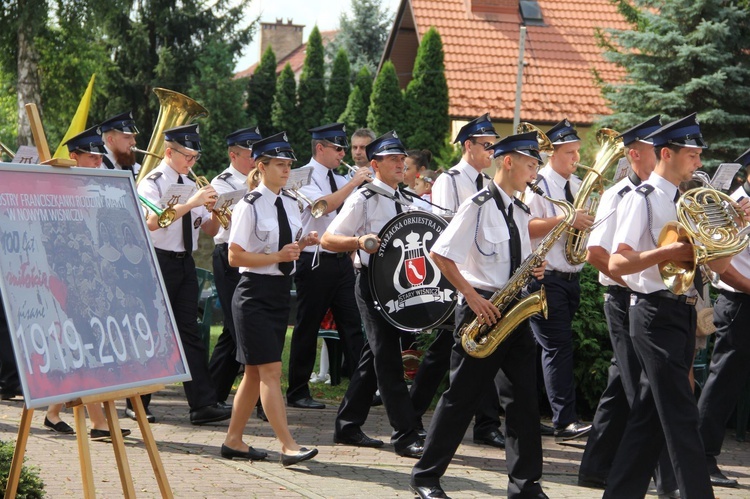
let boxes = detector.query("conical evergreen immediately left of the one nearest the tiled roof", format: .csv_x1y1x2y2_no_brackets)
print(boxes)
367,61,408,137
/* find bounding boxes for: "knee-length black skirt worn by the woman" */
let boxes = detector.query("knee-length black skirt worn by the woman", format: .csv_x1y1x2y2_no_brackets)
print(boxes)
232,272,292,366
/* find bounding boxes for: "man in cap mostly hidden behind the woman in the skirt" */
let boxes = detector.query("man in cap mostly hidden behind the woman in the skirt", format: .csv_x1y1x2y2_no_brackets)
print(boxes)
208,127,262,402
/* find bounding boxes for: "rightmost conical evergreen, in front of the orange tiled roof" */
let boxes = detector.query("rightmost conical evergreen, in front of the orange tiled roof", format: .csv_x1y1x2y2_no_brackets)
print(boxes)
402,27,450,155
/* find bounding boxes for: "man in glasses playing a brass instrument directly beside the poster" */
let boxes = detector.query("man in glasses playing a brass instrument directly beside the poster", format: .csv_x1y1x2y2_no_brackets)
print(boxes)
134,125,231,425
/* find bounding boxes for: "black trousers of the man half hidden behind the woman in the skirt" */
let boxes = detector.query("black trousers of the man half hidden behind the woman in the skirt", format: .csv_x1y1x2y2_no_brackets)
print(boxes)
208,243,241,402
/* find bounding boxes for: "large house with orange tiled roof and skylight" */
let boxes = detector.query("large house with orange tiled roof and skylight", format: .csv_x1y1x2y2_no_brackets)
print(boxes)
381,0,629,139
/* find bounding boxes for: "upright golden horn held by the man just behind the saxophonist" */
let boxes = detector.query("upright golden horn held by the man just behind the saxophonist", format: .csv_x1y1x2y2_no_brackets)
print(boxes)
564,128,625,265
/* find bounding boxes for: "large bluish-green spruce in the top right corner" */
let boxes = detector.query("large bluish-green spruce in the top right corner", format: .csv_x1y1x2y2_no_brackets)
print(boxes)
599,0,750,165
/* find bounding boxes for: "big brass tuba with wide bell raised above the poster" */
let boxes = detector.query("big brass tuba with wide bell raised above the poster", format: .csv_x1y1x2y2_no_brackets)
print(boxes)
135,87,208,184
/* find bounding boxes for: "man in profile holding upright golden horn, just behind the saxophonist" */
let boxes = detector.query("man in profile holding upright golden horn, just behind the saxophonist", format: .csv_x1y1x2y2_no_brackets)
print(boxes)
526,119,594,442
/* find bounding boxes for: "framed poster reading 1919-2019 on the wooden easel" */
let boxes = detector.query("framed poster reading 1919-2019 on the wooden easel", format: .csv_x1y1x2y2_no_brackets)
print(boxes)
0,163,190,409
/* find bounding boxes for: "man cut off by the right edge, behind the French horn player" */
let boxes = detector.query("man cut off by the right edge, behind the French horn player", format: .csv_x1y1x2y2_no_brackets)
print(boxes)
698,149,750,487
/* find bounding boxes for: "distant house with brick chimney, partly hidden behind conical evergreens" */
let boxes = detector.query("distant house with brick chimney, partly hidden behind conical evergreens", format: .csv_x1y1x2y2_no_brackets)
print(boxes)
234,19,338,81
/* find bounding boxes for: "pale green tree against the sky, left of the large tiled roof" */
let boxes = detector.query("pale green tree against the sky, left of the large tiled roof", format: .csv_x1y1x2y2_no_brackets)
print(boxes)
328,0,393,72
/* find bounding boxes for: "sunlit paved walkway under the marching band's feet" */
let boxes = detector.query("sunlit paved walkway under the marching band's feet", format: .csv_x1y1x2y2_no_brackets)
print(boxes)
0,386,750,499
